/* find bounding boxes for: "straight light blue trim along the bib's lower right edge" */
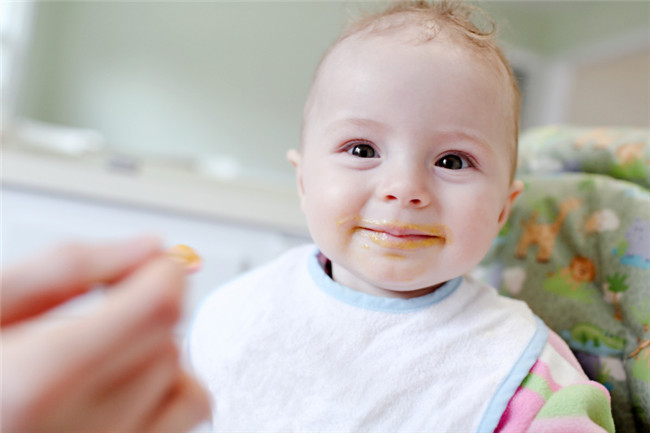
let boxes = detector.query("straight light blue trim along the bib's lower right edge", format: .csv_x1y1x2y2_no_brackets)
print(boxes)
477,316,548,433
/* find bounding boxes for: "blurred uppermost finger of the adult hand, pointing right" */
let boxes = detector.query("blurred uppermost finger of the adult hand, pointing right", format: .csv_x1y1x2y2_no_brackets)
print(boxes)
0,237,160,326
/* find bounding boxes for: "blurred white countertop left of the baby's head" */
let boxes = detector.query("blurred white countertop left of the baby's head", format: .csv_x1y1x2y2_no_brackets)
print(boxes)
0,145,307,236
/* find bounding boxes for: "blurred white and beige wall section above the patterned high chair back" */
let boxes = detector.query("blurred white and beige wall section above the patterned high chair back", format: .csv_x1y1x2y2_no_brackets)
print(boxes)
507,25,650,129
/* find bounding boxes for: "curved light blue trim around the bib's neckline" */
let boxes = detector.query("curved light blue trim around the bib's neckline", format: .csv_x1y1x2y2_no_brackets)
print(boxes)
307,246,463,313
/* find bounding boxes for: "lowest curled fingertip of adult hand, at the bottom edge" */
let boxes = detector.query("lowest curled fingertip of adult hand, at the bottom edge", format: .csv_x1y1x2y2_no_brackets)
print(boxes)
140,373,210,433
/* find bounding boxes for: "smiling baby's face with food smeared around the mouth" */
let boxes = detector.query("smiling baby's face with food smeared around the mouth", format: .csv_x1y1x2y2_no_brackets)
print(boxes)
290,36,519,297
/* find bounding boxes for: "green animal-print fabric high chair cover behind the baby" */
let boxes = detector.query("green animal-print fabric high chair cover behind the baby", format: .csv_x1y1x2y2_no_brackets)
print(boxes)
475,127,650,432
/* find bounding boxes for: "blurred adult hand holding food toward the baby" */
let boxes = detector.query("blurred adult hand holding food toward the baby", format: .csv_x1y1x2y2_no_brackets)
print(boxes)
0,238,209,433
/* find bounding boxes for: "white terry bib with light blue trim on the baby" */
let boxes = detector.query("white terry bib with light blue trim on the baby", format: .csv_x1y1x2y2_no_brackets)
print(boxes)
189,246,547,432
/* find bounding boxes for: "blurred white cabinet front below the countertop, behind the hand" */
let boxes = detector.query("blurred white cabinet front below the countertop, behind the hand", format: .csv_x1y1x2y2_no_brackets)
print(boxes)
0,185,308,337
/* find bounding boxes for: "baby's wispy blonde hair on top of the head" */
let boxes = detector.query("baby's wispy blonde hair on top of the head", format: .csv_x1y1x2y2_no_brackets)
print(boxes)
303,0,521,179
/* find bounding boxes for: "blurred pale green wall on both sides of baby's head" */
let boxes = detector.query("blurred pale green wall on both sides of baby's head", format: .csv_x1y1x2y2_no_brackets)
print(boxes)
19,1,650,182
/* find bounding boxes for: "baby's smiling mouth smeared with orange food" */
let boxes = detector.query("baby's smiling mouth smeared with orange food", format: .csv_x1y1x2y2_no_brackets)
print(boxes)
355,219,452,250
